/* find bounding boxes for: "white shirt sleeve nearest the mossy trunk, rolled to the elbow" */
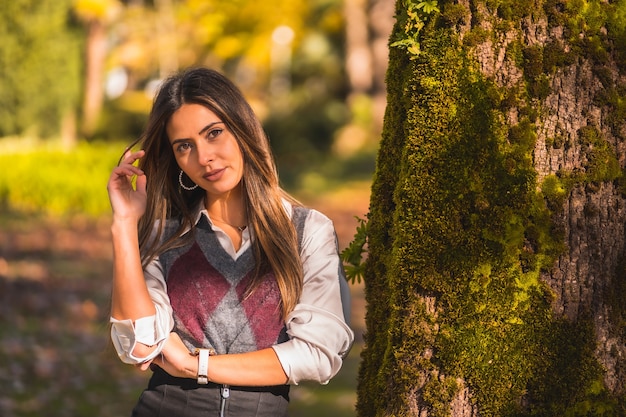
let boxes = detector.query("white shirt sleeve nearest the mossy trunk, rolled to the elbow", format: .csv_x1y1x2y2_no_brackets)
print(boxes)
273,210,354,384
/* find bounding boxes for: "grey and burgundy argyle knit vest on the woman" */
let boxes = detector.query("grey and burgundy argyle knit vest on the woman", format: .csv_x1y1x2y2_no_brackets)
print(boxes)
160,207,308,354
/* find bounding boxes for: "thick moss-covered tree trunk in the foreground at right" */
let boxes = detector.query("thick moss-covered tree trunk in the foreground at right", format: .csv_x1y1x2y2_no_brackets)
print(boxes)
357,0,626,417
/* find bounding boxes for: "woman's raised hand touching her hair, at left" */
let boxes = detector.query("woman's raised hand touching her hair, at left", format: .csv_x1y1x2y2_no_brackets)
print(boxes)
107,150,147,221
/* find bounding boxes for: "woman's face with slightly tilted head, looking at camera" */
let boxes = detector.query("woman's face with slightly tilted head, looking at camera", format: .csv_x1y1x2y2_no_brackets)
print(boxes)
166,104,243,200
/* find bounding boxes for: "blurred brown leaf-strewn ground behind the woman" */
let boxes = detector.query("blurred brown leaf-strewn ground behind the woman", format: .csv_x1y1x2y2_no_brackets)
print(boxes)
0,184,369,417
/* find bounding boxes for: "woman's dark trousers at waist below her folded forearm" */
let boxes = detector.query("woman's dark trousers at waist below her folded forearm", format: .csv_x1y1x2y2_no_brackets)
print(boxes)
132,366,289,417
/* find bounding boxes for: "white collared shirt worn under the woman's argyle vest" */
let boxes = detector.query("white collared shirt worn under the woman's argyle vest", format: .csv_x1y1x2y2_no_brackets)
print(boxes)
111,201,354,384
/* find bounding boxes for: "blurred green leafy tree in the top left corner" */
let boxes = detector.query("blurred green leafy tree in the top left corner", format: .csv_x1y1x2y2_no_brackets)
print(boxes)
0,0,82,143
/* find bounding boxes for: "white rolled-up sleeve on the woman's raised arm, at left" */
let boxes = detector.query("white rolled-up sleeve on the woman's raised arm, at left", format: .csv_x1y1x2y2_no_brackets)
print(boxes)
111,259,174,364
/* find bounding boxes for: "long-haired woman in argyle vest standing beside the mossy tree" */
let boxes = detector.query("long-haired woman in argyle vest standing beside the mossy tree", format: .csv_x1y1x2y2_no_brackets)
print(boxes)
108,68,353,417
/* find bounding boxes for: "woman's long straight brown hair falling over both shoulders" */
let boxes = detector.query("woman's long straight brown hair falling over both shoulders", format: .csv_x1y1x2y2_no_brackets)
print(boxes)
125,68,303,317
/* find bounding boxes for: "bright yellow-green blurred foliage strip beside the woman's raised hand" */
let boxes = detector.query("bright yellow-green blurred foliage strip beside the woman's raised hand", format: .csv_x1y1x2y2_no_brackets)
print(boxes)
0,142,124,216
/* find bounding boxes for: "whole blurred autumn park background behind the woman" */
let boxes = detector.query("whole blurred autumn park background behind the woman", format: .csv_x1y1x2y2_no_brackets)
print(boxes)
0,0,395,417
